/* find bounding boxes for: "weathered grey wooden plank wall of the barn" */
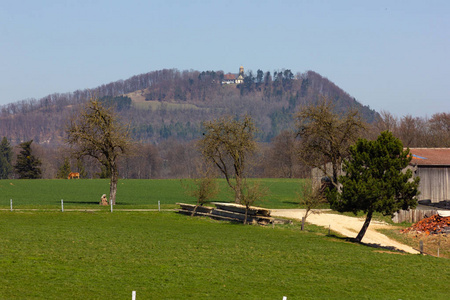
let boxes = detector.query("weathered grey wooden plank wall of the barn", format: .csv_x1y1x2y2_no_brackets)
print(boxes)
416,166,450,203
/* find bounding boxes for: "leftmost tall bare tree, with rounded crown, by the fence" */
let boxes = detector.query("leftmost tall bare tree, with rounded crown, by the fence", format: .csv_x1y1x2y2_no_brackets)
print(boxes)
66,98,131,204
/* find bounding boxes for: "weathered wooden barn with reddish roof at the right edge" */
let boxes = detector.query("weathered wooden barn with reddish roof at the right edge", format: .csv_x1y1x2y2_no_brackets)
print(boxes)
409,148,450,203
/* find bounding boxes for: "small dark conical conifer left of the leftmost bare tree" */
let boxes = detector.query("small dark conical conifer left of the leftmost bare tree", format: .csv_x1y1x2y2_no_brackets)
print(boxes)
14,140,42,179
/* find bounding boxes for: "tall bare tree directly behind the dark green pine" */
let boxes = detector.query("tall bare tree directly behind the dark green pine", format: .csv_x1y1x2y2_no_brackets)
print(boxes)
296,98,365,186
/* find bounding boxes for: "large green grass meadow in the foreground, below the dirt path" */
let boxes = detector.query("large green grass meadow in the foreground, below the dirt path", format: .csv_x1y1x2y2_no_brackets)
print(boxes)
0,210,450,300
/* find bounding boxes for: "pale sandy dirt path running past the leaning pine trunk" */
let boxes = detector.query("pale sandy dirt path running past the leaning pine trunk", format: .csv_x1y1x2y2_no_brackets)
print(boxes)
271,209,419,254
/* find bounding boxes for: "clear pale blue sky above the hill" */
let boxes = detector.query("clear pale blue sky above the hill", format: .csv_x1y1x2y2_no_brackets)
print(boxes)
0,0,450,117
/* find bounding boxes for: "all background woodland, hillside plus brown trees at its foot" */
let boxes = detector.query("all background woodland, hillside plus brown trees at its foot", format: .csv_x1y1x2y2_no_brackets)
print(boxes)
0,69,450,179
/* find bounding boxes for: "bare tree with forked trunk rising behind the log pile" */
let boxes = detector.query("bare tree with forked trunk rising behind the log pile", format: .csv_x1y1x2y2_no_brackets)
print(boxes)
199,115,256,203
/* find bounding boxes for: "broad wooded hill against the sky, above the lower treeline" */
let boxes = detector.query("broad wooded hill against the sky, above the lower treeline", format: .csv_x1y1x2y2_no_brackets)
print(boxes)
0,69,378,145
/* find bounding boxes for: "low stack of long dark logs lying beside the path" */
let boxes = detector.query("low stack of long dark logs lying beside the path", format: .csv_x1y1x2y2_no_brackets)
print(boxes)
177,202,291,225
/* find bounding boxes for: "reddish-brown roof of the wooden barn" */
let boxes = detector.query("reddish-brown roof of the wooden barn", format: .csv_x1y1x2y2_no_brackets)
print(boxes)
409,148,450,167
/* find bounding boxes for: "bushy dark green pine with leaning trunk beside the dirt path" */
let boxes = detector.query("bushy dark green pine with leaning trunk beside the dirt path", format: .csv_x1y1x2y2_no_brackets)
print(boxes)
330,131,420,242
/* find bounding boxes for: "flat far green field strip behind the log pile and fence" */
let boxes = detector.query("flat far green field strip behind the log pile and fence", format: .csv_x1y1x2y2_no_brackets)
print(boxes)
0,179,303,209
